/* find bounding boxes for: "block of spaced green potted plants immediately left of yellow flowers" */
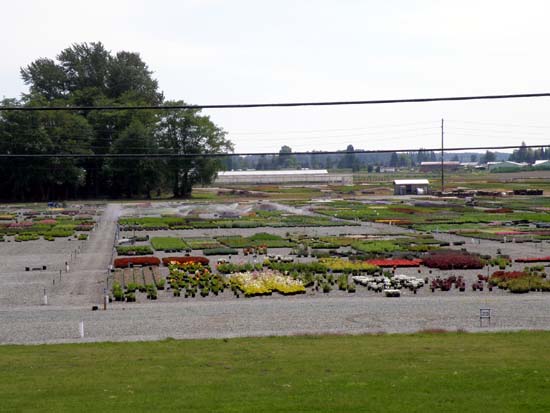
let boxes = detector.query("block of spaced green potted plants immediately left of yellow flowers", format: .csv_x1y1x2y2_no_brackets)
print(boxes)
168,263,228,298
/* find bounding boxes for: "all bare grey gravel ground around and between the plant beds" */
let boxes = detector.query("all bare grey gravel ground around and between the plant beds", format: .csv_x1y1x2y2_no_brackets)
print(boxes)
0,200,550,344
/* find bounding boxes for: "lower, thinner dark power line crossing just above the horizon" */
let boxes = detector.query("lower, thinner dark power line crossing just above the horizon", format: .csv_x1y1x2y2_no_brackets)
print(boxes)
0,145,548,159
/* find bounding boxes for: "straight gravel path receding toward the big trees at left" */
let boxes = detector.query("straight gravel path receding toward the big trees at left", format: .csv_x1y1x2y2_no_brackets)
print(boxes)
52,204,121,305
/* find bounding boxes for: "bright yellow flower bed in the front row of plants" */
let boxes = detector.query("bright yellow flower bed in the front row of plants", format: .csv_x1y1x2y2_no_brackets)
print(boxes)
228,270,306,297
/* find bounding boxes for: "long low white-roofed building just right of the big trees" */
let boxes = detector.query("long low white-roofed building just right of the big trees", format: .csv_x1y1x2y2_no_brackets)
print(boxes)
214,169,353,185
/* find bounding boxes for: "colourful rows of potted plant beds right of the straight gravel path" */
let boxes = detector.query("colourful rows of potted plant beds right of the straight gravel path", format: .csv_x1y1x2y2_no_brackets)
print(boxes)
103,197,550,302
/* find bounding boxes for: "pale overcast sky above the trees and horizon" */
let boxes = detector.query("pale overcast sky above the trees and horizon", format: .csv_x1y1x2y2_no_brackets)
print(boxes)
0,0,550,152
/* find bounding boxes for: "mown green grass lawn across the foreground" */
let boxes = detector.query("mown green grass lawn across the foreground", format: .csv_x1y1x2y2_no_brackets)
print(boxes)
0,332,550,412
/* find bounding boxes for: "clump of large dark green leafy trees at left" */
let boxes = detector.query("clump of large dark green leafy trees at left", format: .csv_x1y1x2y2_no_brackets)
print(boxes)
0,43,233,200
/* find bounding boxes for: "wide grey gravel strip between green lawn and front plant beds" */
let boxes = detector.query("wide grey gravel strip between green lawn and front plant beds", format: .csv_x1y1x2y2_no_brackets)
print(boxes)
0,293,550,344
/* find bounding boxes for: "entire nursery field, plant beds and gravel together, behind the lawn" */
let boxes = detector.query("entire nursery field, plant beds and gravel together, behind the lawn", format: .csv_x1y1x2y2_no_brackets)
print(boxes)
0,197,550,343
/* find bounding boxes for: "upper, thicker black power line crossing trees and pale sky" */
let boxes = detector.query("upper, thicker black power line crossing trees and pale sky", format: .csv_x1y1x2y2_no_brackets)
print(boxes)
0,93,550,112
